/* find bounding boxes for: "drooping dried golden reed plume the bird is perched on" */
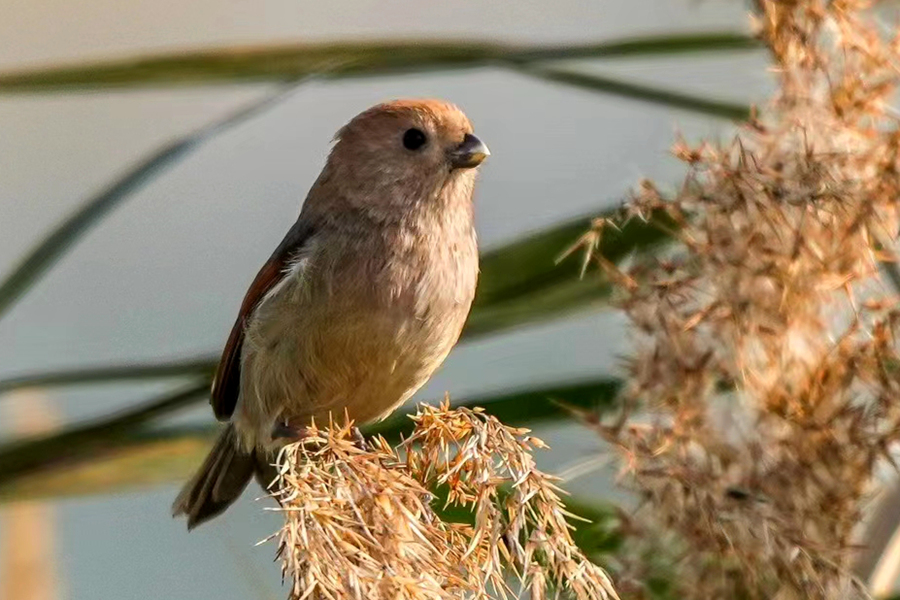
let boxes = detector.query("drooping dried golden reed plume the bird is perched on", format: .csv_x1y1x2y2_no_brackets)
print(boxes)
275,404,616,600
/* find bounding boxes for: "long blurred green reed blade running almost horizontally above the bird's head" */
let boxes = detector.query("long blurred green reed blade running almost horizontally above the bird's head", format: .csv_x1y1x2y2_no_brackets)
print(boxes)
0,32,760,94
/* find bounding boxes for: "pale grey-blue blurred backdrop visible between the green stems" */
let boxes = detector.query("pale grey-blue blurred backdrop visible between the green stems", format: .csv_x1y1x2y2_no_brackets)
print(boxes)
0,0,769,600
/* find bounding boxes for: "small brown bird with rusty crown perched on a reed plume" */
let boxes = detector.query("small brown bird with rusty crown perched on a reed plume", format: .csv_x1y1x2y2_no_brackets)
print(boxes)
173,100,490,529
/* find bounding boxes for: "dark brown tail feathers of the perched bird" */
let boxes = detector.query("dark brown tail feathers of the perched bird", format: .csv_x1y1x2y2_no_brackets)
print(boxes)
172,425,273,529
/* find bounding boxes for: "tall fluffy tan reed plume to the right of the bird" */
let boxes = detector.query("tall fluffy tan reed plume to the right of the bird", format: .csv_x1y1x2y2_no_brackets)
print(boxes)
580,0,900,599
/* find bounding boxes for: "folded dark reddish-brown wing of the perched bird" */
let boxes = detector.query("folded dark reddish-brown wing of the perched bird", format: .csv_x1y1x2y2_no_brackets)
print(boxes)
210,216,314,421
